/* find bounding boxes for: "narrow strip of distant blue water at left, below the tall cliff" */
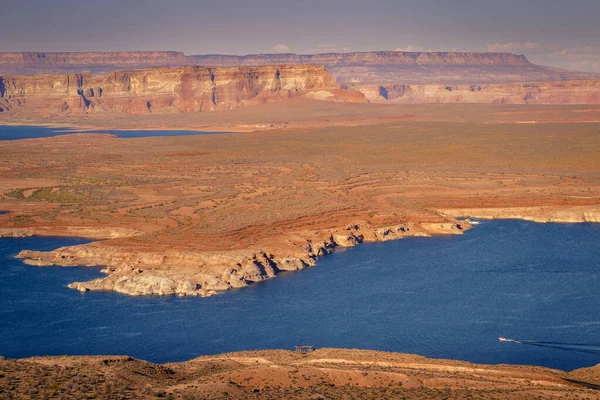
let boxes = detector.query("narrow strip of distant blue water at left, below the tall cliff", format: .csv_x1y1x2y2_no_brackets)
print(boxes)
0,125,232,140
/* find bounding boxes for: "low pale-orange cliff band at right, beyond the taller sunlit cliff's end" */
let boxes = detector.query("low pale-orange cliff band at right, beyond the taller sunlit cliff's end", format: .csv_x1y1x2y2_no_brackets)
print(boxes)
354,80,600,104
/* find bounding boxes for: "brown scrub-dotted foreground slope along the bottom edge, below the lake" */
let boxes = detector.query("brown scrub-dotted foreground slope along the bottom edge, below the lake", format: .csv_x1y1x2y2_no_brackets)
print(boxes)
0,349,600,399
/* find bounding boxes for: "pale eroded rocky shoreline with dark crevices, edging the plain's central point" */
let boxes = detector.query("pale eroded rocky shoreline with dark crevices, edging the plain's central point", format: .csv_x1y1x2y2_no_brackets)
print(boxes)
16,220,464,297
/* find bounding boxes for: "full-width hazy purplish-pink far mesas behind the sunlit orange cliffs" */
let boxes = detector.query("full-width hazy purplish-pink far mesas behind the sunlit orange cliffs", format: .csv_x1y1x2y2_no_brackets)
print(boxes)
0,51,600,84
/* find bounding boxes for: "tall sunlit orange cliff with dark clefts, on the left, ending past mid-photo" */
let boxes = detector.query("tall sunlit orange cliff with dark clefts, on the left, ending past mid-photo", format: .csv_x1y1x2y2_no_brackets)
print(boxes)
0,65,356,116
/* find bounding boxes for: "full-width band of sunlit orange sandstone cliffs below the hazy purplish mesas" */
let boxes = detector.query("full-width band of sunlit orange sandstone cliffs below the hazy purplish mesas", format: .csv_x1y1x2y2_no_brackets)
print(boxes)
0,65,600,117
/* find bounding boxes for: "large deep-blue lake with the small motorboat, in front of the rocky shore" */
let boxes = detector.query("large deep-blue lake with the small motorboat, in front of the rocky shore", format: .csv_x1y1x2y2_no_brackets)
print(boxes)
0,221,600,370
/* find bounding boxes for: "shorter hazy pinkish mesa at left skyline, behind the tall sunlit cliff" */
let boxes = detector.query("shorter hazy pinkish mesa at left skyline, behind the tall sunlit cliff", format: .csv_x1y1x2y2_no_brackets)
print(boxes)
0,51,191,75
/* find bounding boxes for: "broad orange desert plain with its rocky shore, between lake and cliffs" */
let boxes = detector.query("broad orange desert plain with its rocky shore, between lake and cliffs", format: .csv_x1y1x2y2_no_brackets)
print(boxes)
0,100,600,296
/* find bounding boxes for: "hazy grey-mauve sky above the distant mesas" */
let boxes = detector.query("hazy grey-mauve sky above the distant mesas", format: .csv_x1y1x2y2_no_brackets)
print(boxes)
0,0,600,72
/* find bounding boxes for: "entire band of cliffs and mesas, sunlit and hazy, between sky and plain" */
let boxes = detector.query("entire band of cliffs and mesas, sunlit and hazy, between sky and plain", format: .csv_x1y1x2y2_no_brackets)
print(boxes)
0,51,600,117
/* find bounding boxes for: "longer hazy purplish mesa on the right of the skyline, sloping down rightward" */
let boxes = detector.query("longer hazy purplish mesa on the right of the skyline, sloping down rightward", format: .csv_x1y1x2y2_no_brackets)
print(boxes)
189,51,600,84
